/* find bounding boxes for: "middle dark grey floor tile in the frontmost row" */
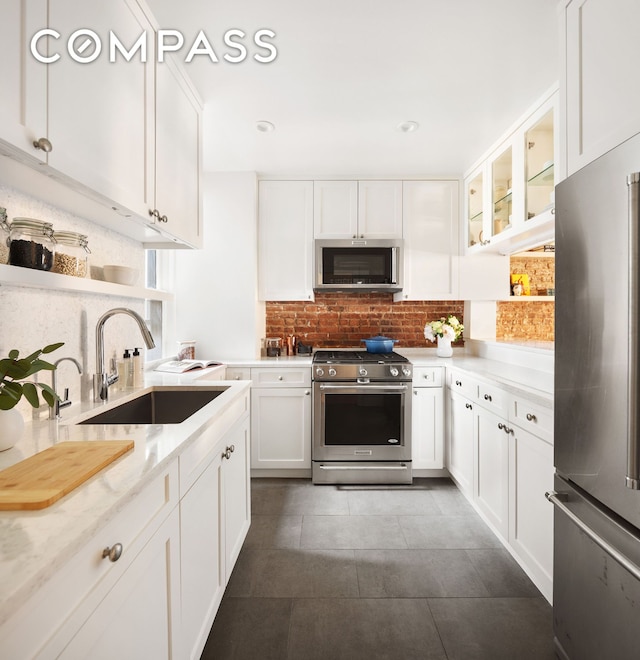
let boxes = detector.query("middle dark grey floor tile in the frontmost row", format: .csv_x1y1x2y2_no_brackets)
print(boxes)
288,598,446,660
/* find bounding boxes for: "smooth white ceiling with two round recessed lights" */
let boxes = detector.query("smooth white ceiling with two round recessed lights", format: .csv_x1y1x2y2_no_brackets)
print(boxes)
147,0,558,176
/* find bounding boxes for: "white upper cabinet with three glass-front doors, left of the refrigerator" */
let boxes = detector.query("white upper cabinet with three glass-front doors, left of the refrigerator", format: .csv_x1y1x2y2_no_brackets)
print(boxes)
463,88,560,254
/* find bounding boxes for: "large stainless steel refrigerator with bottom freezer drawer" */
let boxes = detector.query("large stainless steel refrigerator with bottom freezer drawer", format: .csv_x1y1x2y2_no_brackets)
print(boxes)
547,134,640,660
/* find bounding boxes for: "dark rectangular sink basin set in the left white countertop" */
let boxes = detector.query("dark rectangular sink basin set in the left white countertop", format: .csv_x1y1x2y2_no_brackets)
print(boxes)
78,387,227,424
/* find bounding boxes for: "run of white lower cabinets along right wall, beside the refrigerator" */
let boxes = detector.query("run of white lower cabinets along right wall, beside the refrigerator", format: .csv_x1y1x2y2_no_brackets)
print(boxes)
446,369,554,602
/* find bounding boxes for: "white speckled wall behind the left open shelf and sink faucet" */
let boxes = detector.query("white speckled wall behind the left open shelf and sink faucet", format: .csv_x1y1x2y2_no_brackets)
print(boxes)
0,181,144,419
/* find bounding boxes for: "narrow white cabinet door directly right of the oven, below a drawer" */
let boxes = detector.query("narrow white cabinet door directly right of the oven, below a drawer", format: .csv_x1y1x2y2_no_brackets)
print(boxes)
411,387,444,470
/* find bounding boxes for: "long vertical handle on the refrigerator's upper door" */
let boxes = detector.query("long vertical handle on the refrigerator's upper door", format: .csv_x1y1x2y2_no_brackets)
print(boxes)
625,172,640,490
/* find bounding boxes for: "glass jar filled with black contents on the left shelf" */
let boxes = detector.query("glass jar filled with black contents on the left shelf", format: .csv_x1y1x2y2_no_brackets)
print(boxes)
9,218,55,270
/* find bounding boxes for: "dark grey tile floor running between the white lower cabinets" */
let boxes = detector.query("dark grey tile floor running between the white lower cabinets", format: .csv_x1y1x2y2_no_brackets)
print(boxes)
201,479,555,660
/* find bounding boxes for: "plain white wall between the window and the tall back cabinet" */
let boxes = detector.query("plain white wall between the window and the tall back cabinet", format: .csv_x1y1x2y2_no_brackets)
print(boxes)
166,172,265,361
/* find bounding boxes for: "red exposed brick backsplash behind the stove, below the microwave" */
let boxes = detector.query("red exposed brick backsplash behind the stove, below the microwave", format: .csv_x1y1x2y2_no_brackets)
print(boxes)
265,293,464,348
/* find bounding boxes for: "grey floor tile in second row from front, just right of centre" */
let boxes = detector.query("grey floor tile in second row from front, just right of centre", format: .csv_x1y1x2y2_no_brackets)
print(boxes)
356,550,490,598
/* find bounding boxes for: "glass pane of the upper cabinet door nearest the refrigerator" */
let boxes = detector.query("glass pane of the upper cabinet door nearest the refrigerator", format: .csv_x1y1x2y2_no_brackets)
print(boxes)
524,110,554,221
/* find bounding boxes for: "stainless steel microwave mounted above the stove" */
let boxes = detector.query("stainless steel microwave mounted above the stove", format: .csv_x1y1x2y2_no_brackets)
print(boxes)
313,238,402,292
